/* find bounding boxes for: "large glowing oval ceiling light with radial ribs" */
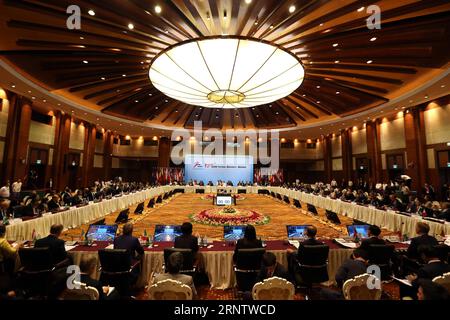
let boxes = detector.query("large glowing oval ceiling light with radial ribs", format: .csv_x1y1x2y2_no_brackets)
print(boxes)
149,37,305,108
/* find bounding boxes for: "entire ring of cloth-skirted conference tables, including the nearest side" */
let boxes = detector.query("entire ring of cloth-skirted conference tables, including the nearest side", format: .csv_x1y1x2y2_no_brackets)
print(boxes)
2,186,436,289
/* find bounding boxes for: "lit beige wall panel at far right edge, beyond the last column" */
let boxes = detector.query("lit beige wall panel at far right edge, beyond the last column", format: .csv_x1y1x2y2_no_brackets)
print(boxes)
424,103,450,144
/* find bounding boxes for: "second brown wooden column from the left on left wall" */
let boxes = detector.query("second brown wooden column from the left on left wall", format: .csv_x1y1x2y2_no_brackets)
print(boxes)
52,111,72,190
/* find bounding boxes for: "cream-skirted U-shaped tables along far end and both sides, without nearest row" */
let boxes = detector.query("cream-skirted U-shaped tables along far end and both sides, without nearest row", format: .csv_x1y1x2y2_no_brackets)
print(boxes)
6,182,450,240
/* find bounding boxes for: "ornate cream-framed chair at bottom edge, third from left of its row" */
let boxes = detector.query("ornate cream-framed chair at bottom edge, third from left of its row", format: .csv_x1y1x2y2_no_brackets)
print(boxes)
252,277,295,300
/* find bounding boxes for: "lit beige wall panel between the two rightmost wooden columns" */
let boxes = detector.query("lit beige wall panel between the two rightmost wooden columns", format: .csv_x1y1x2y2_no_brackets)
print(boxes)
380,117,405,151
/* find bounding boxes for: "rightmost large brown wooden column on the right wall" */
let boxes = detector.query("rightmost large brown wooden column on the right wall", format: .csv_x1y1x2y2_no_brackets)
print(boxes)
404,108,428,192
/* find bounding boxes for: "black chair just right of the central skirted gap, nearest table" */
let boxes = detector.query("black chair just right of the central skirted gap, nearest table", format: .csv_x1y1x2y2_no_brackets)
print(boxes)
234,248,266,293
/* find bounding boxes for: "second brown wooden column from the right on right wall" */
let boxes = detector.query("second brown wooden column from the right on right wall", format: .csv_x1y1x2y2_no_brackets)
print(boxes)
366,120,381,184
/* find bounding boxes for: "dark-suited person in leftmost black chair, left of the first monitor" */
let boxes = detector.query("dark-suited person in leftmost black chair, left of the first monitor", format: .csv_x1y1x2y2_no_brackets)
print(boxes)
34,224,70,268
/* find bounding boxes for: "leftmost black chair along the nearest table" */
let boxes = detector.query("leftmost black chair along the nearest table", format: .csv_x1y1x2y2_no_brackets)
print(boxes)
19,247,56,297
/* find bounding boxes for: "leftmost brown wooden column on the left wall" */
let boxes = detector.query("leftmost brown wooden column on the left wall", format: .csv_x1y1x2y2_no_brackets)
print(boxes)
3,94,31,185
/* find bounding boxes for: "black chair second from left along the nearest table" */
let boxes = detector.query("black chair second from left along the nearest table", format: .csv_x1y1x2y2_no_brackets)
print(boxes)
98,249,140,296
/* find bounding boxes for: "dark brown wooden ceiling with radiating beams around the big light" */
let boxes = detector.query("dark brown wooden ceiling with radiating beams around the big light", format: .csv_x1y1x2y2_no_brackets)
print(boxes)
0,0,450,129
